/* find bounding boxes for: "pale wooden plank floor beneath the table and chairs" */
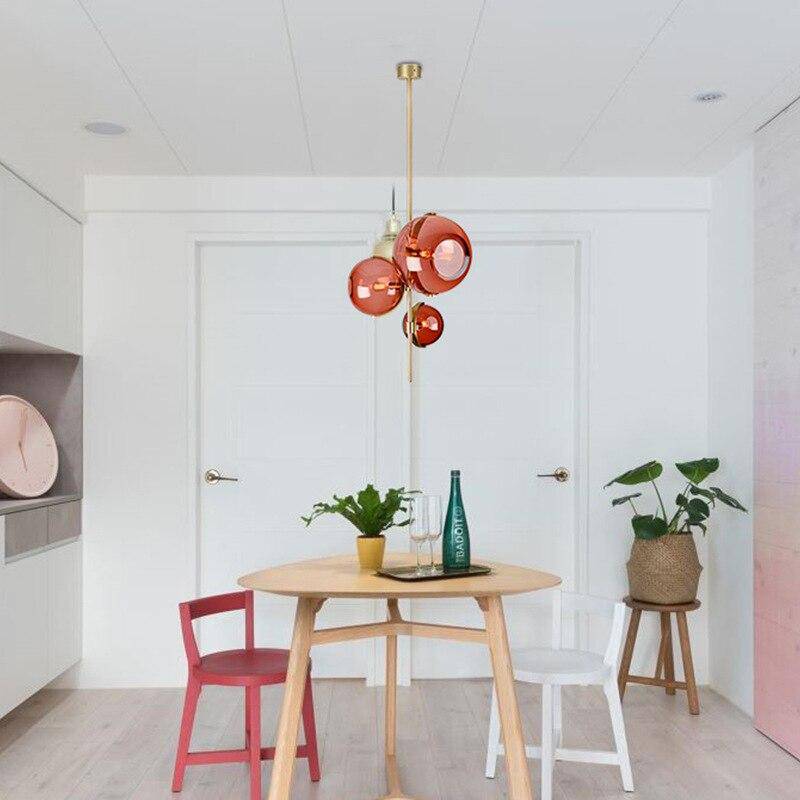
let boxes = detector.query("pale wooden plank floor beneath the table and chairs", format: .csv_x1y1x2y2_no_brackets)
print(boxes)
0,681,800,800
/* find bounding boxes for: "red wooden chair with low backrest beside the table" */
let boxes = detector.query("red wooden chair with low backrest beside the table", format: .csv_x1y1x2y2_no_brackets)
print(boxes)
172,591,319,800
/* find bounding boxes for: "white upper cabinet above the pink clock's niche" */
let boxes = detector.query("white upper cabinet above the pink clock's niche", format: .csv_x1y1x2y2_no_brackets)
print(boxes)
0,167,82,353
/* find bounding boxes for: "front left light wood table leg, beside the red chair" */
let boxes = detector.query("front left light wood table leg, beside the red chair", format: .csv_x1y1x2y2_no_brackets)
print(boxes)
267,597,320,800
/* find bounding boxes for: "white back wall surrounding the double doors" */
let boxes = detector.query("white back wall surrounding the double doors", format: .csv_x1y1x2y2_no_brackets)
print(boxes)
73,178,710,686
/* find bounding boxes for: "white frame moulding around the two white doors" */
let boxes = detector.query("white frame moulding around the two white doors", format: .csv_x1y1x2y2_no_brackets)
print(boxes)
186,225,596,686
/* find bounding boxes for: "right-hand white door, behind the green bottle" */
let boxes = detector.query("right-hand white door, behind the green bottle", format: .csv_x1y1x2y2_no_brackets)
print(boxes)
411,239,577,678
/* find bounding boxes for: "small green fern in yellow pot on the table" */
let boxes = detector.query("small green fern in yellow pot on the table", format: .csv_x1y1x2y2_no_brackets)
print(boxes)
300,483,412,570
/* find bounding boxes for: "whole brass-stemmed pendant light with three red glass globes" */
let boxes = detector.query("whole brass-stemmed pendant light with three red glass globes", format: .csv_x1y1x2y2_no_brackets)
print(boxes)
348,61,472,382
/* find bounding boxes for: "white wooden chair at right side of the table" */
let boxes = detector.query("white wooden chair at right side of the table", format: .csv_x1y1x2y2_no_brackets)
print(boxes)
486,589,633,800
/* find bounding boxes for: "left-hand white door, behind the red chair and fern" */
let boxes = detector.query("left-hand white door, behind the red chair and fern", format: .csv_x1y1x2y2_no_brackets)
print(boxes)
199,241,388,675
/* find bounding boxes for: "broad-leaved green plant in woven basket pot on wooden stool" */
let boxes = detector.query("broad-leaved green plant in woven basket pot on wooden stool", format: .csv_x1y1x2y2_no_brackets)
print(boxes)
604,458,747,605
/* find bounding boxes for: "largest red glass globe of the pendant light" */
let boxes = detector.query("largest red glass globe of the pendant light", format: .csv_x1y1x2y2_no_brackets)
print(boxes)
394,214,472,295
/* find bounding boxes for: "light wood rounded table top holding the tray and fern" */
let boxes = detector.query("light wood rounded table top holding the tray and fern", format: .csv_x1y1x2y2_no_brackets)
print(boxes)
239,553,561,599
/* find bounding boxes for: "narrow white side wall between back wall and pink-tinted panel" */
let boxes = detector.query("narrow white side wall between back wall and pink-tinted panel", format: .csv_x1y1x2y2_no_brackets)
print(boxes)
708,149,753,714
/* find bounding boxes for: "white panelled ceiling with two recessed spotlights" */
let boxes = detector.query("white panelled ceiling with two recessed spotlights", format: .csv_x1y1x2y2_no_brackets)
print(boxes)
0,0,800,212
